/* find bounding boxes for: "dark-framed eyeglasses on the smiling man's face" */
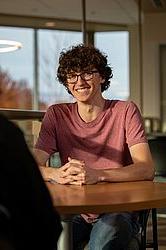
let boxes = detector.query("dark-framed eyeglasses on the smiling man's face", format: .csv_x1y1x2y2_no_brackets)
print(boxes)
67,70,98,84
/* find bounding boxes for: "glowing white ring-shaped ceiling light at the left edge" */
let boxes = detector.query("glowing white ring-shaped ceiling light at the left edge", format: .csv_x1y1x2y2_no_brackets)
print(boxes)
0,40,22,53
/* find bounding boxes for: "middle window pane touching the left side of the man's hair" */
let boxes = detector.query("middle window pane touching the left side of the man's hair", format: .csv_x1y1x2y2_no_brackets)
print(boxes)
38,30,82,106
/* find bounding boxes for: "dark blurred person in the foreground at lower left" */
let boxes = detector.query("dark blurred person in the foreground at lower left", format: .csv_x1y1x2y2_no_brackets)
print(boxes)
0,115,62,250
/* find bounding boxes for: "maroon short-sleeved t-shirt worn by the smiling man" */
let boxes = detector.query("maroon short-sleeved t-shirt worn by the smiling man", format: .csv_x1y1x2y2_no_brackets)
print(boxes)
35,100,147,169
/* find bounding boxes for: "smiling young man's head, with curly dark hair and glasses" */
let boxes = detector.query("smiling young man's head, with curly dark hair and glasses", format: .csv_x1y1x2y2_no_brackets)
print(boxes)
57,44,113,96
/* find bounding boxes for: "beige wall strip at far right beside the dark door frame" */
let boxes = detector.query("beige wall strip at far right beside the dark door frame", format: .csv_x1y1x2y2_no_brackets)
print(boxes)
142,13,166,118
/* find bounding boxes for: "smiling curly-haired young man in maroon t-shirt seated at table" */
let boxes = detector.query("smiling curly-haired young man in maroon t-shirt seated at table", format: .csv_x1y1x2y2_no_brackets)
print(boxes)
35,45,154,250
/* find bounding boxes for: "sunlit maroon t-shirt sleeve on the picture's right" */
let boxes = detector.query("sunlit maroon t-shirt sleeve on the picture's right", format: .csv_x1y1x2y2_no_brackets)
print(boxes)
125,102,147,147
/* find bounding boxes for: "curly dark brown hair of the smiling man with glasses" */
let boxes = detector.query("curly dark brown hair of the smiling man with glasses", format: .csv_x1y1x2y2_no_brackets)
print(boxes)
57,44,113,94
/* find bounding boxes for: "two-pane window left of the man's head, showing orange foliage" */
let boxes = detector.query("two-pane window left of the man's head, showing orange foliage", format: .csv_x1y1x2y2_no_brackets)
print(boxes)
0,27,82,110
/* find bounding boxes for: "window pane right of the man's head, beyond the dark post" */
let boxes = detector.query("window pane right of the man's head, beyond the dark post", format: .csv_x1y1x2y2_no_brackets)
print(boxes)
94,31,130,100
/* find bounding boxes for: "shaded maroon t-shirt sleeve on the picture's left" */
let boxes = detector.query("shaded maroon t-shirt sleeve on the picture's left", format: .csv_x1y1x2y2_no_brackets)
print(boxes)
35,106,57,155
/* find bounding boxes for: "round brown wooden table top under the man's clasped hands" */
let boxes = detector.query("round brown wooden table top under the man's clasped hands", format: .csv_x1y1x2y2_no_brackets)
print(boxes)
47,181,166,215
